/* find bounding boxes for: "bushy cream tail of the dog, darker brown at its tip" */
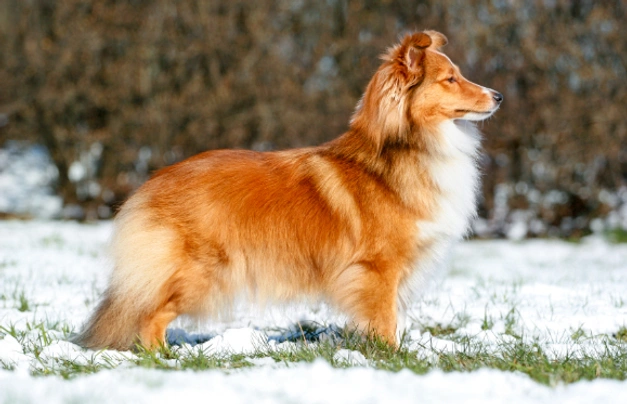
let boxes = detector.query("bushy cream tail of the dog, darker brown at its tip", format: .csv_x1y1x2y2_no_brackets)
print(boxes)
73,197,182,350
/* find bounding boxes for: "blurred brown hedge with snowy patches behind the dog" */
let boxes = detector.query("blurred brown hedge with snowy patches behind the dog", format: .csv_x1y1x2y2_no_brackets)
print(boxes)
0,0,627,239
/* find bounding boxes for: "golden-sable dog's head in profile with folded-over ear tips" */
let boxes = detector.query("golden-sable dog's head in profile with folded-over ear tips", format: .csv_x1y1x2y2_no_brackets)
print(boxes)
353,31,503,144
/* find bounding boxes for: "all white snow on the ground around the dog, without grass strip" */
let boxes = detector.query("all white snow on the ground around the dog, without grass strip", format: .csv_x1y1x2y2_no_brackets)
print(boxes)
0,221,627,403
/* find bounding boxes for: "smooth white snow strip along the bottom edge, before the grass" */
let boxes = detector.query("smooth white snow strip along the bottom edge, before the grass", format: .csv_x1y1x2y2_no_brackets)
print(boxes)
0,359,625,404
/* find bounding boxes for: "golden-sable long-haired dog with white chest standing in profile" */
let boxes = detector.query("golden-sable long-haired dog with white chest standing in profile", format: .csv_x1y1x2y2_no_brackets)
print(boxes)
75,31,503,350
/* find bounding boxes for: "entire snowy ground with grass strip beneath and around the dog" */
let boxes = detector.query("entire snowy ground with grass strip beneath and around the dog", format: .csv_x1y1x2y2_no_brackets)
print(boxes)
0,221,627,403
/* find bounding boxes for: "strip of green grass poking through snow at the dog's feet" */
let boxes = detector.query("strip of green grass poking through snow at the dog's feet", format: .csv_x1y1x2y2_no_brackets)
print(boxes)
0,323,627,386
